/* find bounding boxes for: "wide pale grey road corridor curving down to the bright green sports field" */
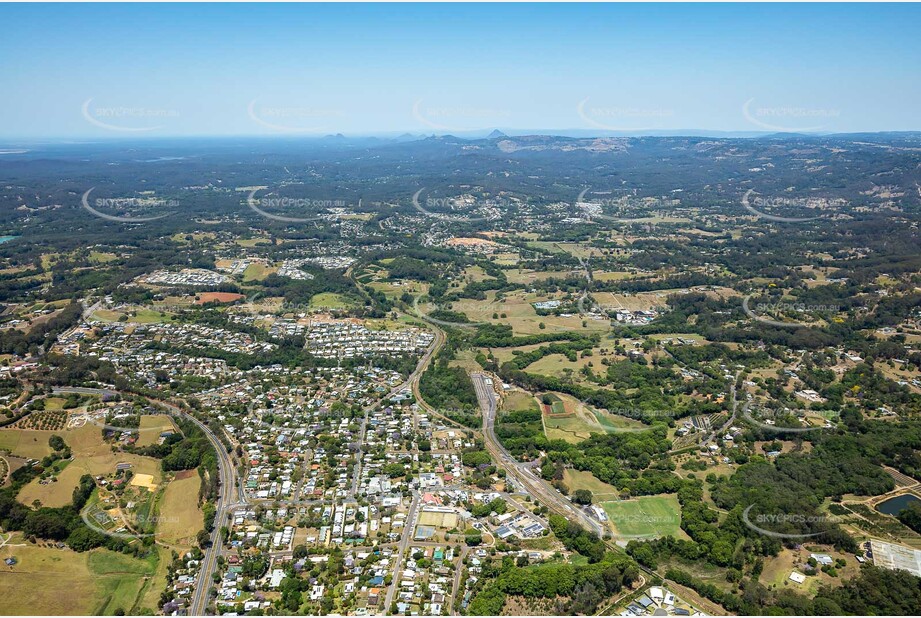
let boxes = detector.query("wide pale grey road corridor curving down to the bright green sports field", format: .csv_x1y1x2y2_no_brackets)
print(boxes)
470,373,605,537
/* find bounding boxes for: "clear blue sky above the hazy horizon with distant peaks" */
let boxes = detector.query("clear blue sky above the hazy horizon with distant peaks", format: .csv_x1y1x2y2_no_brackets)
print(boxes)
0,4,921,138
